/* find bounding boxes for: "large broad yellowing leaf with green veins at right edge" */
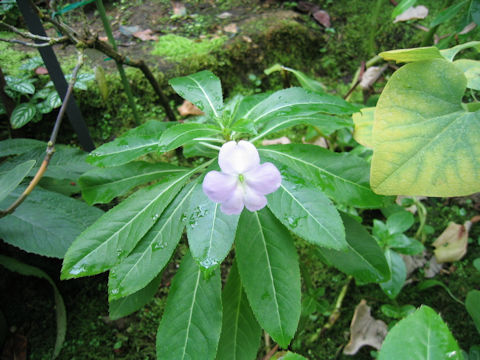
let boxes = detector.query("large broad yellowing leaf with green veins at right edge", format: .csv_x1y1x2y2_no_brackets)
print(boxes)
371,60,480,196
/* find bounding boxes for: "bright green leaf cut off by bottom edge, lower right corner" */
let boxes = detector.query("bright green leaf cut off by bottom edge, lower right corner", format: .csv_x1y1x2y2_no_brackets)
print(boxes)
378,305,463,360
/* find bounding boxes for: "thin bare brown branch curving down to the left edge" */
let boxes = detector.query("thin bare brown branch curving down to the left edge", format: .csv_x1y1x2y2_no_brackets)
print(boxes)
0,52,83,218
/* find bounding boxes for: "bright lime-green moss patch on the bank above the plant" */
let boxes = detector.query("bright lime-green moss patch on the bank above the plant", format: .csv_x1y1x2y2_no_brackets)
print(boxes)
152,34,226,62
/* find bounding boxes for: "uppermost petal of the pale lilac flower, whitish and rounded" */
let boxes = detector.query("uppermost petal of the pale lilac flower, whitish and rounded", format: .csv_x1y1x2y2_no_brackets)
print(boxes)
218,140,260,174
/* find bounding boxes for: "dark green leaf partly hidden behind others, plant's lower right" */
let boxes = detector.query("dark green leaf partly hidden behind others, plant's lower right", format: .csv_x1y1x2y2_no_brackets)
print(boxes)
318,214,390,283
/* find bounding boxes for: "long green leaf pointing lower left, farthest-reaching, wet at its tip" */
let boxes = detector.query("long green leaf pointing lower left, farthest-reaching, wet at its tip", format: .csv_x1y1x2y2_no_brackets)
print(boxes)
62,169,195,279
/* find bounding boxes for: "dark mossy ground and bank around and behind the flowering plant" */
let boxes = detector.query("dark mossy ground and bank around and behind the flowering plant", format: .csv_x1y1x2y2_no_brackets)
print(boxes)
0,0,480,360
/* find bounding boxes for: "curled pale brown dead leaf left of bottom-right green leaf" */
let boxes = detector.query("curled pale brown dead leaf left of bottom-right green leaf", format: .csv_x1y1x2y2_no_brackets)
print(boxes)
343,300,388,355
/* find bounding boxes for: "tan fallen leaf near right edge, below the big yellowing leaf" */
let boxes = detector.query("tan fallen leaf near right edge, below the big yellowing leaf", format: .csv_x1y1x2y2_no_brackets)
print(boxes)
432,221,472,264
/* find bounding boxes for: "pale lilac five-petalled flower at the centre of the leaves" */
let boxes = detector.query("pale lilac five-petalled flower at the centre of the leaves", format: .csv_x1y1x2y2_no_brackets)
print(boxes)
203,140,282,215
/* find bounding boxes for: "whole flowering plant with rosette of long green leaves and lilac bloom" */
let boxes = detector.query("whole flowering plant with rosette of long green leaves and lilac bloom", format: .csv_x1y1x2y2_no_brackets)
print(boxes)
62,71,396,360
